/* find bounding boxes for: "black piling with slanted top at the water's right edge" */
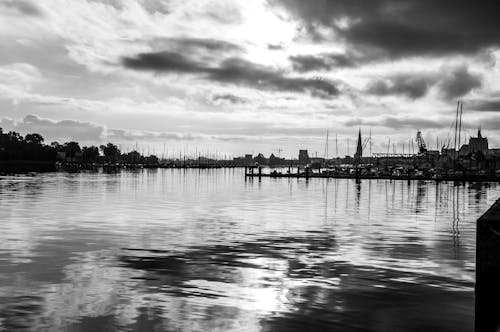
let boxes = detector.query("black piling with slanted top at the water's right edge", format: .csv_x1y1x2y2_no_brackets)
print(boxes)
475,199,500,332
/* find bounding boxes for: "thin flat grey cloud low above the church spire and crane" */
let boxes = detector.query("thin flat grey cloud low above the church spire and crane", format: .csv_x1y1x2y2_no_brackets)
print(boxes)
345,116,443,129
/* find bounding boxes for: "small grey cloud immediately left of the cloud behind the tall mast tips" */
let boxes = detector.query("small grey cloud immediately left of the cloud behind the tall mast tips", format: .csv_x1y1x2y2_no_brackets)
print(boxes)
366,74,433,99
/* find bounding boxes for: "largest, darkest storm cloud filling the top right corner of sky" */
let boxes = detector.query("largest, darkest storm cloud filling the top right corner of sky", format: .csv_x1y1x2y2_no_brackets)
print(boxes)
268,0,500,57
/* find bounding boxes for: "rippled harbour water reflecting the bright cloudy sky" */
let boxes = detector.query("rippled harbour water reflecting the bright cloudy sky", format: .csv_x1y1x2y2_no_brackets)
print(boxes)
0,169,500,331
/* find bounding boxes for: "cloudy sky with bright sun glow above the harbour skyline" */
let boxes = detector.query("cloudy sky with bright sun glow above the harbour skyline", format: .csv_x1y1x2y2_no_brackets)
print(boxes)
0,0,500,158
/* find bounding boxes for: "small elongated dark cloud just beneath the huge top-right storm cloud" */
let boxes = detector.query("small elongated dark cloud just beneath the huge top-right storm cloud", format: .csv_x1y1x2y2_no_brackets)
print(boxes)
289,53,358,72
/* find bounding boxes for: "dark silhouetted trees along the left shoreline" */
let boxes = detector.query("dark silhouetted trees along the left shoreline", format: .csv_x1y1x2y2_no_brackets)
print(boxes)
0,128,159,165
